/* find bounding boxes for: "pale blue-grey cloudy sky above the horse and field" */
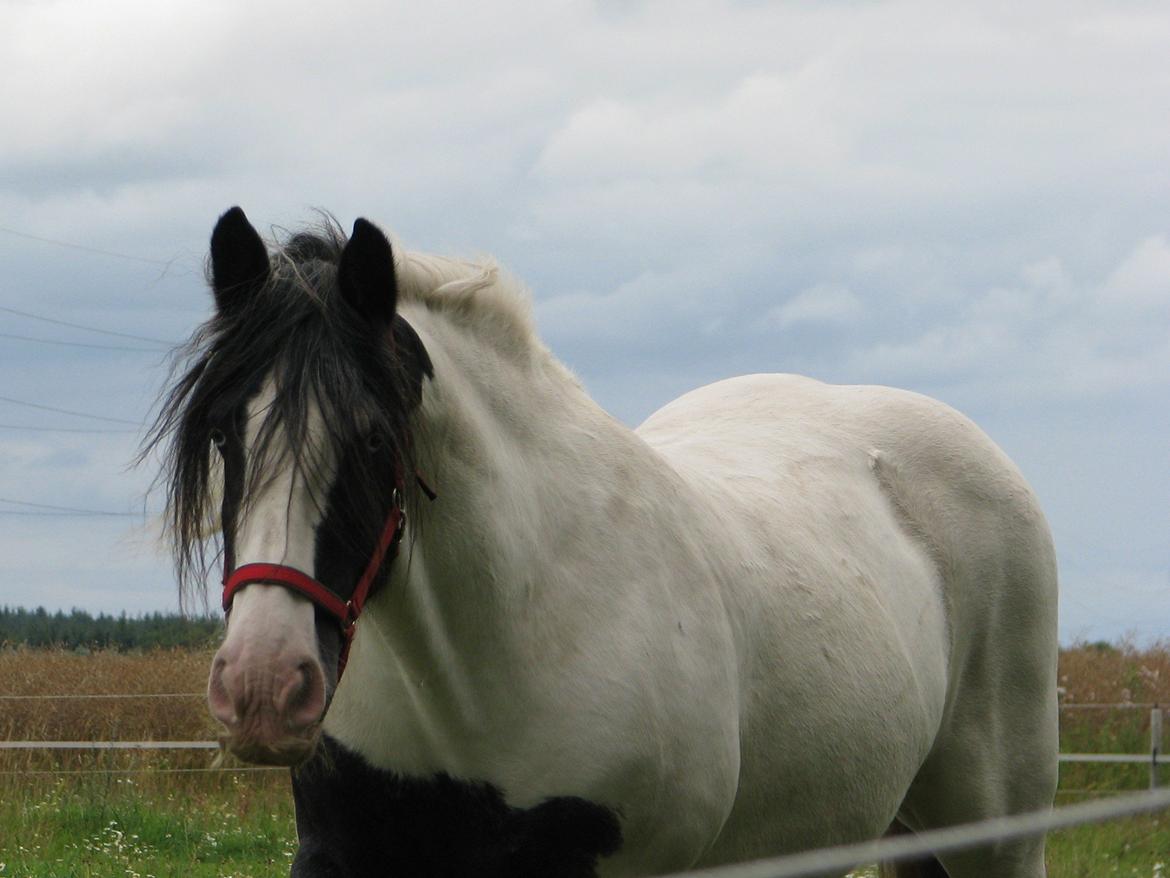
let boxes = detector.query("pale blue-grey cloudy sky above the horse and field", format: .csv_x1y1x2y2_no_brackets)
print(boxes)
0,0,1170,642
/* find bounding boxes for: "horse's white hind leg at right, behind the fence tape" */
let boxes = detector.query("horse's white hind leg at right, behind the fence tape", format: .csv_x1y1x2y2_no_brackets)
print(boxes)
884,613,1058,878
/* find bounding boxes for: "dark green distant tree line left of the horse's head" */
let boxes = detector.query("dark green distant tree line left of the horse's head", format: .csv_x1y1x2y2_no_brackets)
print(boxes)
0,606,223,650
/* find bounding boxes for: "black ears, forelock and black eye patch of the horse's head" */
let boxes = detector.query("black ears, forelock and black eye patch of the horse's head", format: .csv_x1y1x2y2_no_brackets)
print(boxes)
142,207,433,618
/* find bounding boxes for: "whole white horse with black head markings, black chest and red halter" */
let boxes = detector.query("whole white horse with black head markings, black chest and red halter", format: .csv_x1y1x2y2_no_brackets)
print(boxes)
158,208,1058,878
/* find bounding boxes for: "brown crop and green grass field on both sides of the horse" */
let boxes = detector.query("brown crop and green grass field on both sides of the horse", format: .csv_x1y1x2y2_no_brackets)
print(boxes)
0,644,1170,878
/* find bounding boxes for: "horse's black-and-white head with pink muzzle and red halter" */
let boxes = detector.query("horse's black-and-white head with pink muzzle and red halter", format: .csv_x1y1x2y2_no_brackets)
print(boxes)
154,207,431,764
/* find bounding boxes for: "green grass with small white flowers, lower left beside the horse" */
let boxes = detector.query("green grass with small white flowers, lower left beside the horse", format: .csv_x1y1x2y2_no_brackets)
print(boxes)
0,773,296,878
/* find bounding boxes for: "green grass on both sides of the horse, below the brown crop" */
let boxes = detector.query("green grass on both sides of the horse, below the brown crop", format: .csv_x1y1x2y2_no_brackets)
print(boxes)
0,711,1170,878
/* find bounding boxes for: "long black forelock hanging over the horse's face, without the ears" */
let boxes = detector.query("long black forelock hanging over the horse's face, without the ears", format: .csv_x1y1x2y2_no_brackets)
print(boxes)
140,218,431,613
